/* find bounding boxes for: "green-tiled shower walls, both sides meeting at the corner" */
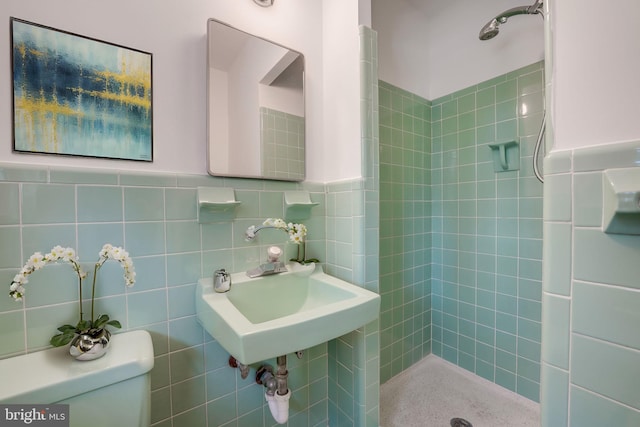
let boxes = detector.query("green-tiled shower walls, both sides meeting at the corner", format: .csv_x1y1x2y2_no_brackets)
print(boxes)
380,62,544,401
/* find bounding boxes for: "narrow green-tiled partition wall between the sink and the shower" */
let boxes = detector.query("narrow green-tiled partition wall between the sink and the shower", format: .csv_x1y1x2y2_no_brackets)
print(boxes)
326,27,380,427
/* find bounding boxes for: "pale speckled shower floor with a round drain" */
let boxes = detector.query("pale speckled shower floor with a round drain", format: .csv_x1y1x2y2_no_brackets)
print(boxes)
380,356,540,427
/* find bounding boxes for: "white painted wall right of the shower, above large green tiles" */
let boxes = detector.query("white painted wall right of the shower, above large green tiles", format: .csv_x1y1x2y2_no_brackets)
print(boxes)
550,0,640,150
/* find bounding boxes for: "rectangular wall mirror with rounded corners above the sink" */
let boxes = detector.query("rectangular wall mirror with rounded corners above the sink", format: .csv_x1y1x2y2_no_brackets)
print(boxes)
207,19,305,181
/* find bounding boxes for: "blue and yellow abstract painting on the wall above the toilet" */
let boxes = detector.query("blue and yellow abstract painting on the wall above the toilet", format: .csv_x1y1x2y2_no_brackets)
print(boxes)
11,18,153,161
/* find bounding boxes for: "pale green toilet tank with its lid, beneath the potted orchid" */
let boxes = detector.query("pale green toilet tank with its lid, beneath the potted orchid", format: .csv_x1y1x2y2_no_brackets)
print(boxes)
0,331,153,427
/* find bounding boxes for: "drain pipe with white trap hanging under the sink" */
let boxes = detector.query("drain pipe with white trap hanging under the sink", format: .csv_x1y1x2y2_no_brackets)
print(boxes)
256,356,291,424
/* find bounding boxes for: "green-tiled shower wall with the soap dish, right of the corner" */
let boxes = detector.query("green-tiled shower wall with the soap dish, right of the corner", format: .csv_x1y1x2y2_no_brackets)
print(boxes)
431,62,544,401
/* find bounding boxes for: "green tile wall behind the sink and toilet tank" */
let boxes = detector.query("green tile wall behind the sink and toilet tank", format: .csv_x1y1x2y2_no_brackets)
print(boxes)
0,164,336,427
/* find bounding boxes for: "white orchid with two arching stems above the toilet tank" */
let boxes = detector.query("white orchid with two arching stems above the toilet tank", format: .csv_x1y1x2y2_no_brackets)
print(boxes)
9,243,136,347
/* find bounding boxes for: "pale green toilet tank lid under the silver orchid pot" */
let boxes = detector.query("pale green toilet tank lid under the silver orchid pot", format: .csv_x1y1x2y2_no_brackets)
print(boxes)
0,331,153,404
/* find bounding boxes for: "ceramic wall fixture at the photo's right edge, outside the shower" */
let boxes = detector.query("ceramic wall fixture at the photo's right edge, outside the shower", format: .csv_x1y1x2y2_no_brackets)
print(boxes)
602,168,640,235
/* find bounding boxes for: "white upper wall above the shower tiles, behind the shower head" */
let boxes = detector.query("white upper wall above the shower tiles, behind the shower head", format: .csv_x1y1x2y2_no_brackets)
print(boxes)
372,0,544,99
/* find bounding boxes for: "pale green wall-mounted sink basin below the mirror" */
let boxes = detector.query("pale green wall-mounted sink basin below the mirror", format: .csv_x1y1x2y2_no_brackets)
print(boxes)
196,266,380,364
